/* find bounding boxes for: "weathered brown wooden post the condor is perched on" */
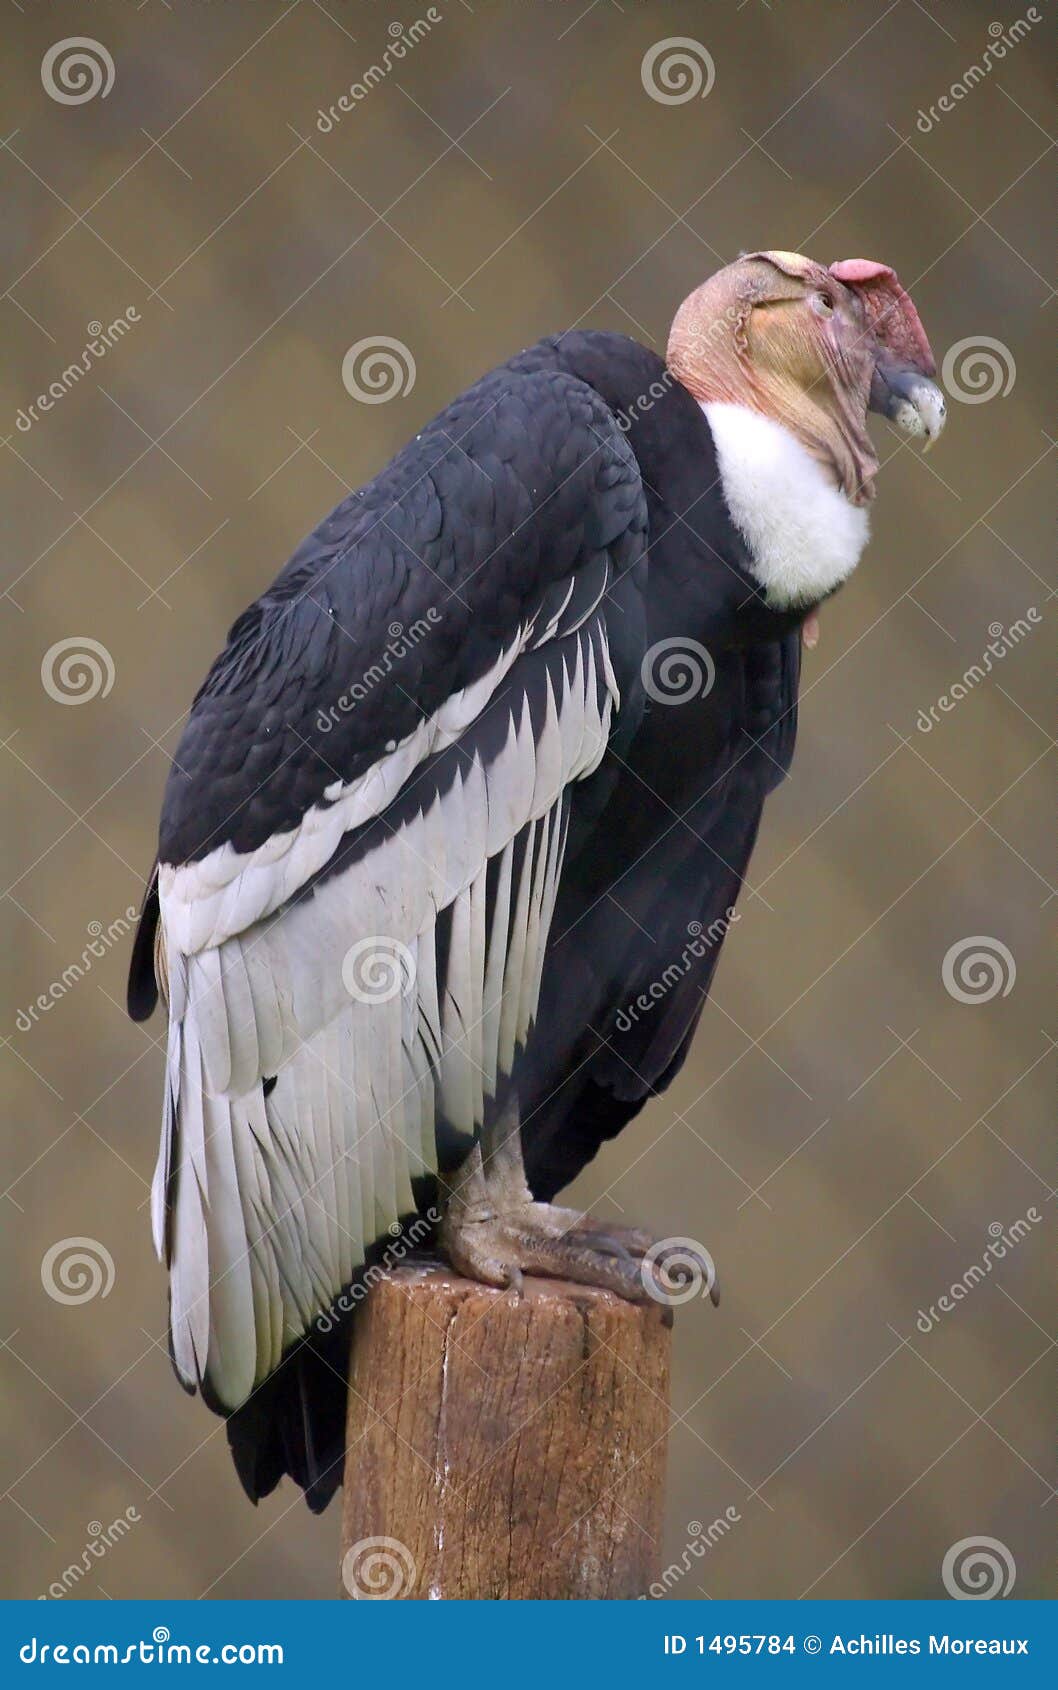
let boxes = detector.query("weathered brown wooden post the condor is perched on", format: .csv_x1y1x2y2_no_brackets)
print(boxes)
341,1266,671,1600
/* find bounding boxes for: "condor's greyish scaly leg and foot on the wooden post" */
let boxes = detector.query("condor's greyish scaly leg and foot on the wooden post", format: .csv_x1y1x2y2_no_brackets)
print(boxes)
439,1099,717,1303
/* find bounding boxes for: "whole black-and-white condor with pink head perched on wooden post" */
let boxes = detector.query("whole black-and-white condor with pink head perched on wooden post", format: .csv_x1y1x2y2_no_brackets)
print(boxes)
128,250,945,1511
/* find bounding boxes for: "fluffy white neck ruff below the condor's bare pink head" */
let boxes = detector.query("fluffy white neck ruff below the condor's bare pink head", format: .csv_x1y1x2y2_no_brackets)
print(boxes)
701,401,870,610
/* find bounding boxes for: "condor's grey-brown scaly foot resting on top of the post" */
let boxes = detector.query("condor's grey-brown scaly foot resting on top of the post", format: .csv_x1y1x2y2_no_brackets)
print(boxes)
441,1193,718,1305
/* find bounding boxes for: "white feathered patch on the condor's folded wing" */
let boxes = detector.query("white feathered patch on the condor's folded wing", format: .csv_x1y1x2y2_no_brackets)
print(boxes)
152,605,619,1408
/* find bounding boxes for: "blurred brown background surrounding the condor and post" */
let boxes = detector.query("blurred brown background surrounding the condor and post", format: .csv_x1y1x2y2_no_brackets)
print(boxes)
0,0,1056,1599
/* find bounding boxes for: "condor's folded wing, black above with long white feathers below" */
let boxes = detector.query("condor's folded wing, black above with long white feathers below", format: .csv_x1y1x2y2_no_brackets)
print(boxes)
134,372,646,1409
